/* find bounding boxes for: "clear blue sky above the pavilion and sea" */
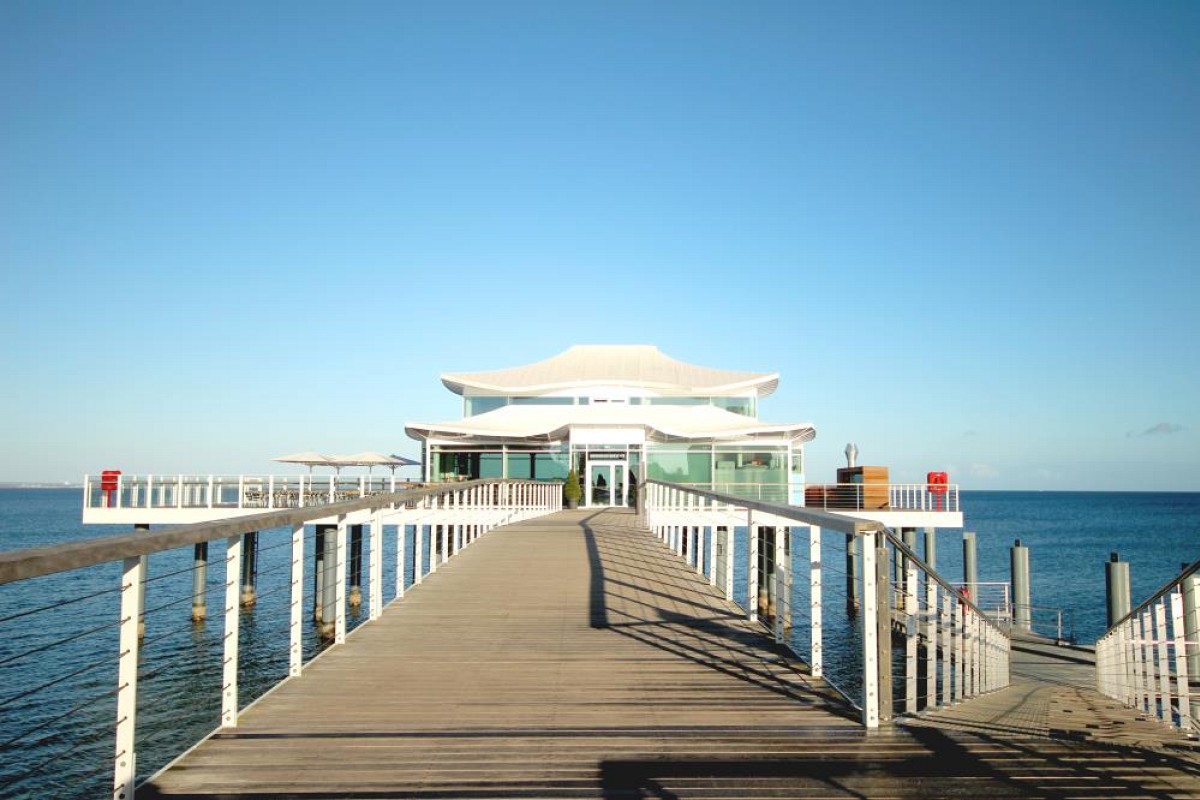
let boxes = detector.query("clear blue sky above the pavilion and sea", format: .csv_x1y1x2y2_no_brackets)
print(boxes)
0,0,1200,489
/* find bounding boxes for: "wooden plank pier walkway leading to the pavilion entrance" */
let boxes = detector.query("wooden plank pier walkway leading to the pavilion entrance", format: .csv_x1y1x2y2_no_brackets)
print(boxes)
145,511,1200,800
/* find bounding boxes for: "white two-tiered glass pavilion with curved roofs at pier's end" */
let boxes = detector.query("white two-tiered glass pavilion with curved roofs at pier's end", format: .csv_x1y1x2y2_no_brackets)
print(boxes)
406,345,816,506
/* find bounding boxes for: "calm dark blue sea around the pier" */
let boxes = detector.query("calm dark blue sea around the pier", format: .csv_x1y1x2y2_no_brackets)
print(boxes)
0,489,1200,798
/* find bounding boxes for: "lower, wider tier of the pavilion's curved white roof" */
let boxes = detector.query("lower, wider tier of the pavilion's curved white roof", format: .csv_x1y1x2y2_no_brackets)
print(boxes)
404,403,816,441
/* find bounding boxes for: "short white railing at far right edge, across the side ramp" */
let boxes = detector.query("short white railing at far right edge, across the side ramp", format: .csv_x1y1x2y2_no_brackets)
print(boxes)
1096,561,1200,732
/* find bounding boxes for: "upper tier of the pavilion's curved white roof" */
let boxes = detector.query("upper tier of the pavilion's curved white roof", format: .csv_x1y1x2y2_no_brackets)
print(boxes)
442,344,779,397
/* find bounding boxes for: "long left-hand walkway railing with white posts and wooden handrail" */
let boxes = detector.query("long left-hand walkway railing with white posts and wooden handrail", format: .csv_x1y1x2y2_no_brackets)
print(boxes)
0,476,562,800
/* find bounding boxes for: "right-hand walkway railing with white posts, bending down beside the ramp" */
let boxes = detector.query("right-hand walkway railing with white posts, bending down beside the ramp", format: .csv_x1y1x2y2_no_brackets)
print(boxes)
640,480,1010,728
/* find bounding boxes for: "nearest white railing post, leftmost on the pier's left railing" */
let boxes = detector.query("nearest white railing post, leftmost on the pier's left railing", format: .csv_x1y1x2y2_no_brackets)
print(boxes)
113,557,143,800
